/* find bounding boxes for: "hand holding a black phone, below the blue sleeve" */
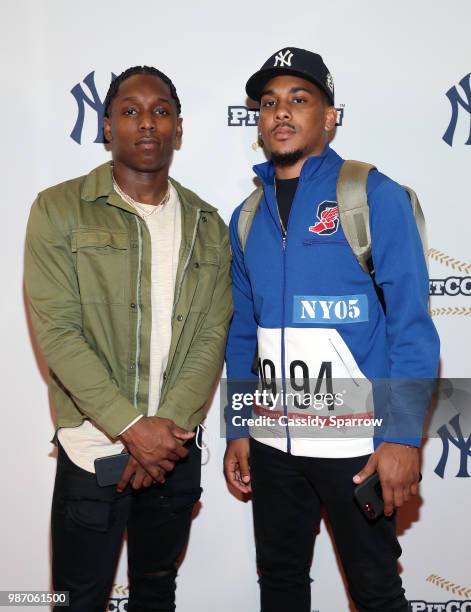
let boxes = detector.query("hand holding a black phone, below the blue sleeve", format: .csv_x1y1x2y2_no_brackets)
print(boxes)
353,442,420,516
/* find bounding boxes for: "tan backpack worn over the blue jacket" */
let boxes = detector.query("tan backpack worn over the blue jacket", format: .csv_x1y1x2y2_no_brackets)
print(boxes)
237,160,428,276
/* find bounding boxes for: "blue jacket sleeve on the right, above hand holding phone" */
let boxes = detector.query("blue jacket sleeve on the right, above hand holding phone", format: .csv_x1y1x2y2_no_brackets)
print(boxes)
368,173,440,446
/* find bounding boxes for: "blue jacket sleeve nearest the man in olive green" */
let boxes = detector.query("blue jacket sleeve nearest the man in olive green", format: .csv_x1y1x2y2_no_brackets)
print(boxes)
226,206,258,440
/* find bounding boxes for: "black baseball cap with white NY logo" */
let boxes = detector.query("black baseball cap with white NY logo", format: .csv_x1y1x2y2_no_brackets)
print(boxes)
245,47,334,105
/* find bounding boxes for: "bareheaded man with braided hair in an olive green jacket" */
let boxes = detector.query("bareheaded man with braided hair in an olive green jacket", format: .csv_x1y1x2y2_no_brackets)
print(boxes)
25,66,232,612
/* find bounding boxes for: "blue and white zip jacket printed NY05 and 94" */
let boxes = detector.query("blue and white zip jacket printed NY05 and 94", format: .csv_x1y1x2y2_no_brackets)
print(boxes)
226,146,439,457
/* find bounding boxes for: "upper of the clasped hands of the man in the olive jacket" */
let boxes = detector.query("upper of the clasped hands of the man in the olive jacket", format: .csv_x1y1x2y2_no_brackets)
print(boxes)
120,416,195,481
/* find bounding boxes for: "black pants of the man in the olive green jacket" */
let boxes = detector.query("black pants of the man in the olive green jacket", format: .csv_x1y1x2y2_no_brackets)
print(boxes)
51,441,201,612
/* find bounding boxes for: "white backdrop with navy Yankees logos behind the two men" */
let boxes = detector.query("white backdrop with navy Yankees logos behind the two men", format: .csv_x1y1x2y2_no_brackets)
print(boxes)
0,0,471,612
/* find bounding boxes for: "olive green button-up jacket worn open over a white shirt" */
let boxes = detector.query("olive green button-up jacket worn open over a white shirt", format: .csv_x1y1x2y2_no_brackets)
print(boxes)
25,162,232,437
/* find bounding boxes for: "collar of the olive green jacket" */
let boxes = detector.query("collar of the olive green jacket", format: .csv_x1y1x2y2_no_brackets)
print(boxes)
81,161,217,212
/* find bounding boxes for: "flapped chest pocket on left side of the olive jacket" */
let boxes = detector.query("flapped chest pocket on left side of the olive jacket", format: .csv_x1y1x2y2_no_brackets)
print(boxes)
72,229,129,304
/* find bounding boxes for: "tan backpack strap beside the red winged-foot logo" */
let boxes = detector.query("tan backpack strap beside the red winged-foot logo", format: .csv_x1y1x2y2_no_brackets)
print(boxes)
337,160,375,274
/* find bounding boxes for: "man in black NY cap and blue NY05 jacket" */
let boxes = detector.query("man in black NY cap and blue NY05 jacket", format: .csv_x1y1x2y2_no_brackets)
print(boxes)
224,47,439,612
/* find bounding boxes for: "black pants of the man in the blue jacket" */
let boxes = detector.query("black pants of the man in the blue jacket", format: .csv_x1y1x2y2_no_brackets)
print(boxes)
250,440,408,612
